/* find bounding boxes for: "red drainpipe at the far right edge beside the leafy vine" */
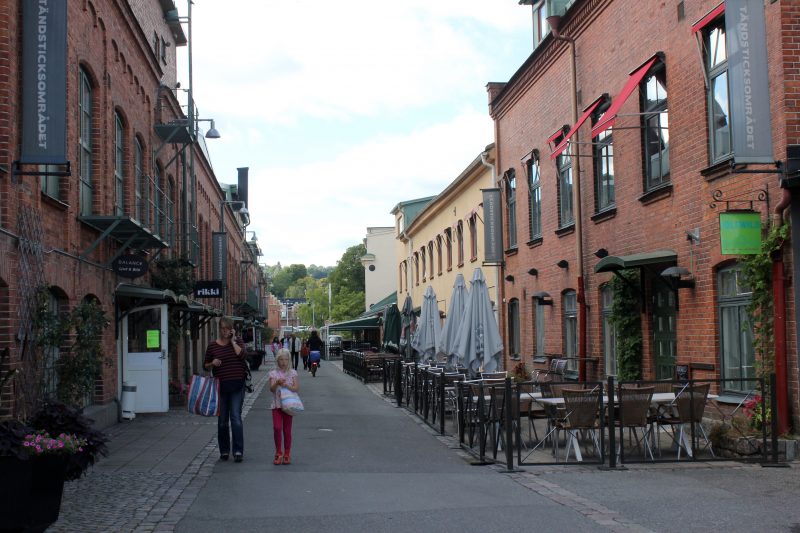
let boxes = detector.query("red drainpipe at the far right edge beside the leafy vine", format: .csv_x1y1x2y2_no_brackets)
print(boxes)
772,189,792,435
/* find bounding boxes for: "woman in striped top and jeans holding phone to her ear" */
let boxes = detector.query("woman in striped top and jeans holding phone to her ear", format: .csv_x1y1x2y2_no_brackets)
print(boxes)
203,317,247,463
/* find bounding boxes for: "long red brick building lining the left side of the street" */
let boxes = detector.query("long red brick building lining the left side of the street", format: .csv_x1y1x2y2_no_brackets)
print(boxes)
0,0,263,423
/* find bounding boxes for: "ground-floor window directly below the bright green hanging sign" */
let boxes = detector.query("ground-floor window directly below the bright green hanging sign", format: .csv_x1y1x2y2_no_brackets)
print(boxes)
717,266,756,392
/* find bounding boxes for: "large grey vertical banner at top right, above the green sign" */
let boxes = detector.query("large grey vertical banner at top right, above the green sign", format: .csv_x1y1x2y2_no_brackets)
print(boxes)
725,0,775,163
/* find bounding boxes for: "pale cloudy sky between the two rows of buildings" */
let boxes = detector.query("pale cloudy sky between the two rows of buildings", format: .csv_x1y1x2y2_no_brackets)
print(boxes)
176,0,532,266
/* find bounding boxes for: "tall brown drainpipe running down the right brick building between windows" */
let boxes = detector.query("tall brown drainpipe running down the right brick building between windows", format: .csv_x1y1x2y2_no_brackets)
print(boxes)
547,16,586,381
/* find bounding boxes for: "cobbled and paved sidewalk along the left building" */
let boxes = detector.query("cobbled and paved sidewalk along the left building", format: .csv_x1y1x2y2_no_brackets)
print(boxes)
48,361,274,533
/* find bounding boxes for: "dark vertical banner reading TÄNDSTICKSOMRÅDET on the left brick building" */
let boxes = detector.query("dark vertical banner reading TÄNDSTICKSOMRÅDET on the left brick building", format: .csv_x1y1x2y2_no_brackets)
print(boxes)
20,0,67,165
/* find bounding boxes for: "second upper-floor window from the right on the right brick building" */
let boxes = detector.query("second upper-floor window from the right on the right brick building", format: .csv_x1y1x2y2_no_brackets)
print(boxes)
640,62,669,191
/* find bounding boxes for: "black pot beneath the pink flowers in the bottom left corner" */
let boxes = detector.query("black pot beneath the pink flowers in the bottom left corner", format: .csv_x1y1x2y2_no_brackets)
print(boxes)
0,455,67,532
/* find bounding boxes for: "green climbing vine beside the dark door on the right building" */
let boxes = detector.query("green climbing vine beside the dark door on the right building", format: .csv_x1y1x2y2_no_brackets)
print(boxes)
609,270,643,381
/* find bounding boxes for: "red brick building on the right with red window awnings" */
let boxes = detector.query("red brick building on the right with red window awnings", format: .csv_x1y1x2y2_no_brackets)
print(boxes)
488,0,800,429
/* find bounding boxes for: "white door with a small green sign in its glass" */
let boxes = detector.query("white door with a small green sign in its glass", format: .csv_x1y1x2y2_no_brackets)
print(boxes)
122,304,169,413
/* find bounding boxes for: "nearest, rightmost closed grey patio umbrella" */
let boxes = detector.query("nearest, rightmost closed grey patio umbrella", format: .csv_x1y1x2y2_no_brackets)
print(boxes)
453,268,503,375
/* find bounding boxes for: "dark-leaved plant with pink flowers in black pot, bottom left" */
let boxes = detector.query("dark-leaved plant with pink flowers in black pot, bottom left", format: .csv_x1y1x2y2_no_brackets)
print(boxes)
0,401,107,531
